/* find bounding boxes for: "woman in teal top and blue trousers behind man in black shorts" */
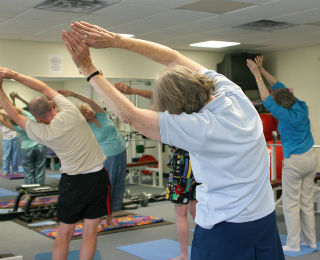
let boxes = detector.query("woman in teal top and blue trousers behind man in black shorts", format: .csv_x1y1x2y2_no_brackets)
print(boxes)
59,90,127,211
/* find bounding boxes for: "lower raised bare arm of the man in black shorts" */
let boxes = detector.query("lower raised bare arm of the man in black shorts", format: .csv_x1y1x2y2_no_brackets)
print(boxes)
0,75,28,130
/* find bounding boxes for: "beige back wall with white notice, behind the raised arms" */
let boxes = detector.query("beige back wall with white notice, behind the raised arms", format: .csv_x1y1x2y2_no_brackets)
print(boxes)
0,40,223,79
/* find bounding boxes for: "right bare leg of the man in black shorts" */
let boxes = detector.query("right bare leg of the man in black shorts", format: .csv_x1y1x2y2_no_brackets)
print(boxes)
80,218,101,260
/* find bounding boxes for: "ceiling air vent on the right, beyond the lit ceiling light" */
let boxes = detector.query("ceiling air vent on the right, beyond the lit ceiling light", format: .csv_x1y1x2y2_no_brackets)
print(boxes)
235,20,295,32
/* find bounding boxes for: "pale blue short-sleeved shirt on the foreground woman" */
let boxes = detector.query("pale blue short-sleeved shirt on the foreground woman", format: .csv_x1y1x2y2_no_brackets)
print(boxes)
159,69,275,229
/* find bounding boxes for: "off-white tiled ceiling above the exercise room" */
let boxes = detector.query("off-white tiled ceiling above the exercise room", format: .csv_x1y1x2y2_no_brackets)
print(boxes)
0,0,320,52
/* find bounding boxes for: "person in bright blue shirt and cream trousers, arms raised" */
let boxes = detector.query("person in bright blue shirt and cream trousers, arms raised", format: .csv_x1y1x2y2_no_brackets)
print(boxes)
247,56,318,252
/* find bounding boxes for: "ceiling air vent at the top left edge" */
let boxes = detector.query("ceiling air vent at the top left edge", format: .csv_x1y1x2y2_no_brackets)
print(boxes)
34,0,120,14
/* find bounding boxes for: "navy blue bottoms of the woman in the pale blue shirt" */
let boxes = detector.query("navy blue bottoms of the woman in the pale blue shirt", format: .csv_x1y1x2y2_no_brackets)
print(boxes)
191,212,284,260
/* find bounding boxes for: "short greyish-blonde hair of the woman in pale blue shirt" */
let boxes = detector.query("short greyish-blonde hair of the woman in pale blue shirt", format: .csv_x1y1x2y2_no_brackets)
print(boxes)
152,65,215,114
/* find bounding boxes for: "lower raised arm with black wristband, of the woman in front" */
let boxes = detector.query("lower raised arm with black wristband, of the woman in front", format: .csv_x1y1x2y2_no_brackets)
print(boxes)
61,31,161,141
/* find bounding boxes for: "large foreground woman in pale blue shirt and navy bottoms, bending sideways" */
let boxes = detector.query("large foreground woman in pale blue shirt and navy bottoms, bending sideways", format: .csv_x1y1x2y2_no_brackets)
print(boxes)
62,22,284,260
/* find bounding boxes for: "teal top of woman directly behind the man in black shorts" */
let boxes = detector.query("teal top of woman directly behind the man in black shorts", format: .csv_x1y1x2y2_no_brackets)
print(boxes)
88,113,126,156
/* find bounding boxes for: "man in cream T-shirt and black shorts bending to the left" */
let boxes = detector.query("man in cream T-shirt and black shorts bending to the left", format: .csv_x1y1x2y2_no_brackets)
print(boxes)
0,67,110,260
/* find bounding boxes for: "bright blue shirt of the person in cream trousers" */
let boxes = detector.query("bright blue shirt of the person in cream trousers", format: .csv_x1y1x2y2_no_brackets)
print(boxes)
262,81,314,158
